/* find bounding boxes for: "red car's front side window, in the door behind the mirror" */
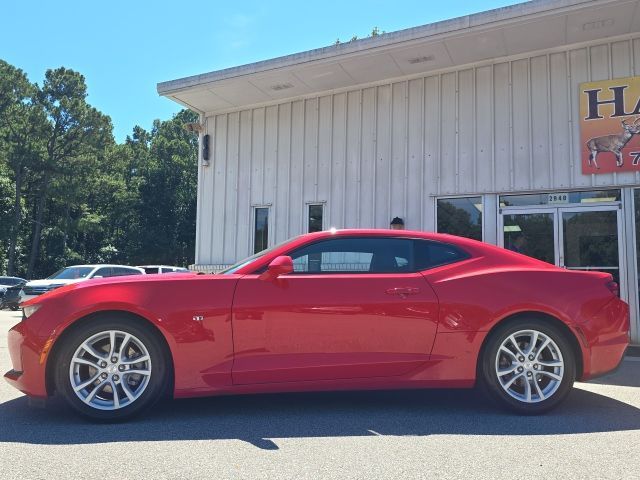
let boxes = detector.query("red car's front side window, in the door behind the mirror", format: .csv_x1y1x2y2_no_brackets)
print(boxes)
289,237,413,274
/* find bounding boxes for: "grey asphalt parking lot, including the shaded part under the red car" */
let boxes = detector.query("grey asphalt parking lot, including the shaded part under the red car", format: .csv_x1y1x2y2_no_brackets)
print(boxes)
0,311,640,480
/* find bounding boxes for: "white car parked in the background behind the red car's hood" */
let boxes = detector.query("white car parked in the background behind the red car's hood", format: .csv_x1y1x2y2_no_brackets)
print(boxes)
20,265,145,303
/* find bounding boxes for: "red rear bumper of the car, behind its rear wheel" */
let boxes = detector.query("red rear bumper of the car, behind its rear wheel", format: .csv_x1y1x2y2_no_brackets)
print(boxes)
577,298,630,380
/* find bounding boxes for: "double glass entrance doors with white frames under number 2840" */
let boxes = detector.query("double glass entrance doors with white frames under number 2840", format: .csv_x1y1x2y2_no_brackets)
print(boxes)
498,205,626,298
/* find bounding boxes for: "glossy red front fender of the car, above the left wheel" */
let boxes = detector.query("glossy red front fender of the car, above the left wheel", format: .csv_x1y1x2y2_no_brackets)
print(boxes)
27,275,237,396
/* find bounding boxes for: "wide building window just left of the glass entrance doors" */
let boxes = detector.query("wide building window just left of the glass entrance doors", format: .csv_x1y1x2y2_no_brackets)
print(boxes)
436,197,482,241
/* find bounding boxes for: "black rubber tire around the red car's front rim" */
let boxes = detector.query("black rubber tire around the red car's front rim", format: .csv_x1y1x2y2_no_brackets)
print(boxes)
50,315,169,422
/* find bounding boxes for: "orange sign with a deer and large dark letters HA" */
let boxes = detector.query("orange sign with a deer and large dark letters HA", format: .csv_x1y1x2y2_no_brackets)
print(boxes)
580,77,640,174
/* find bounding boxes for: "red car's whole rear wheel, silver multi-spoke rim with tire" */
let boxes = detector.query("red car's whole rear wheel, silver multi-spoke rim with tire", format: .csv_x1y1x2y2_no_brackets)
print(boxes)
479,318,576,414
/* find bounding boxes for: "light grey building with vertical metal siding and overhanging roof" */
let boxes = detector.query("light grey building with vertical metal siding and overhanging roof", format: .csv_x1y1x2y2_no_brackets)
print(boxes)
158,0,640,343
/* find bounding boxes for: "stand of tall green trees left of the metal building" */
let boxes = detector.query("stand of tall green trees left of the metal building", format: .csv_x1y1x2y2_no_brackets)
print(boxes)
0,61,198,278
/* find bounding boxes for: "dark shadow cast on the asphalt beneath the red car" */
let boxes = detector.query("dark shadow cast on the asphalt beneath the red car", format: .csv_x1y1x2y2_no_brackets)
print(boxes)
0,388,640,449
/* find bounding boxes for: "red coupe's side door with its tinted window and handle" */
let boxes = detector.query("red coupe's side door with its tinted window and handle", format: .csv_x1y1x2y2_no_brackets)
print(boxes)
232,236,438,384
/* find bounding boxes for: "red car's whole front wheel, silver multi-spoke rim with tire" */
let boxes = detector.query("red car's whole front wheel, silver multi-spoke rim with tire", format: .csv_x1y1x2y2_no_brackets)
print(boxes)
55,317,167,421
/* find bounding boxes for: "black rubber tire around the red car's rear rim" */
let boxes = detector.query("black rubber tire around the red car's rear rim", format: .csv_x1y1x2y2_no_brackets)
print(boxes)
478,317,576,415
